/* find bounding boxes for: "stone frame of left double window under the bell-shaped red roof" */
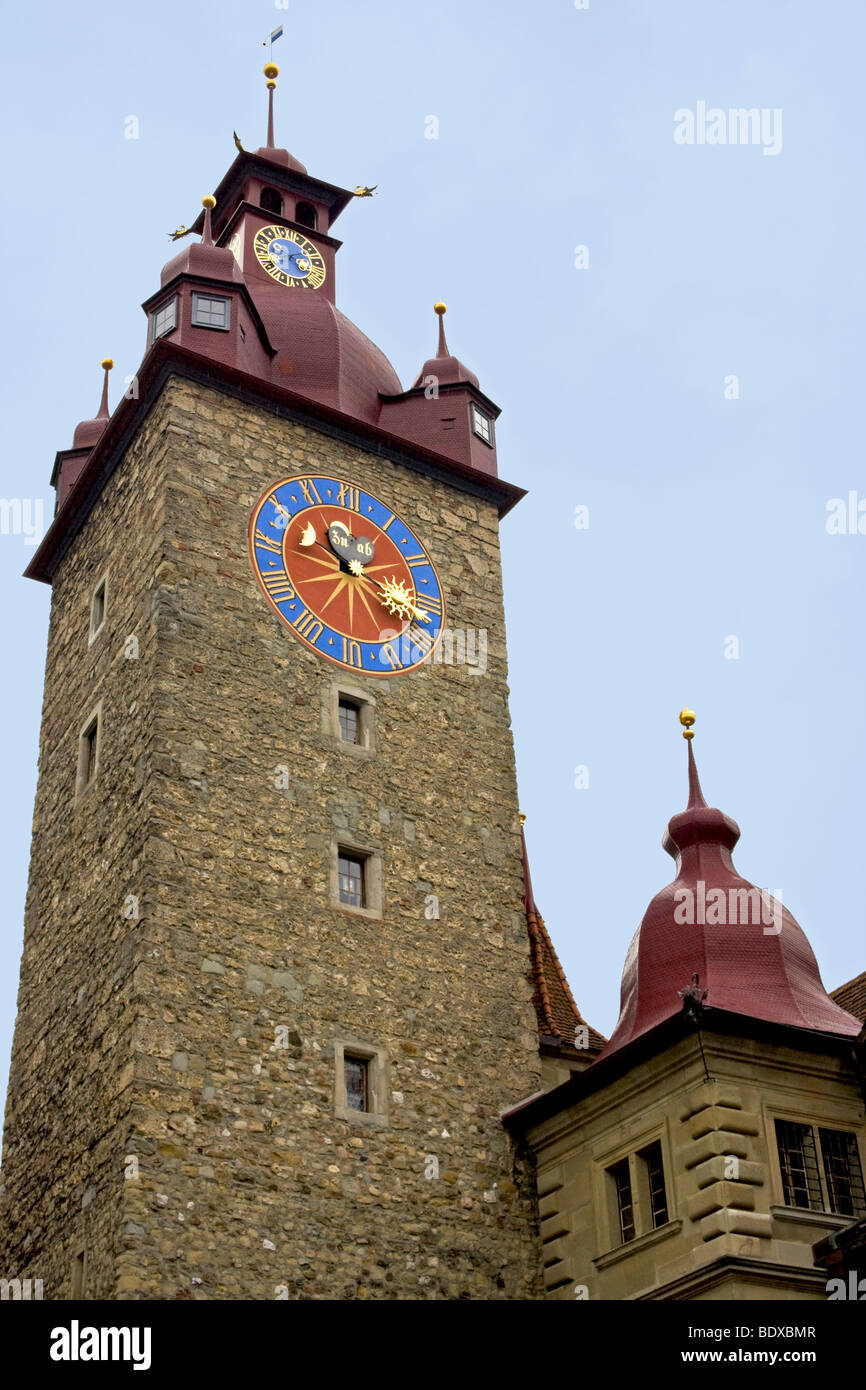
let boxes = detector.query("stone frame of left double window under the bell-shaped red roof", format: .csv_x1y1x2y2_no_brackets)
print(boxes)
591,1120,678,1259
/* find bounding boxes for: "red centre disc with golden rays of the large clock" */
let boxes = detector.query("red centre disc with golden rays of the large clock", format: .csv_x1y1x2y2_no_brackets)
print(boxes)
282,503,416,642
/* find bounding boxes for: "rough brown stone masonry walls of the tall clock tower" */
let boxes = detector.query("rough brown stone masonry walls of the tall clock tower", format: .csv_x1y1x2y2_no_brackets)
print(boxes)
0,375,541,1300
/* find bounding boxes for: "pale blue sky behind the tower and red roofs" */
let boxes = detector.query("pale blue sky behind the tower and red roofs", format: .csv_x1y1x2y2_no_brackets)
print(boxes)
0,0,866,1117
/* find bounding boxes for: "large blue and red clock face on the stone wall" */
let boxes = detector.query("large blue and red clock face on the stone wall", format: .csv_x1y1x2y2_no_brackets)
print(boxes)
250,474,445,676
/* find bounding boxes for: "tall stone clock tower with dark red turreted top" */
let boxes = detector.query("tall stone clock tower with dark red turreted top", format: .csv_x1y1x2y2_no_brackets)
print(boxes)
3,64,553,1300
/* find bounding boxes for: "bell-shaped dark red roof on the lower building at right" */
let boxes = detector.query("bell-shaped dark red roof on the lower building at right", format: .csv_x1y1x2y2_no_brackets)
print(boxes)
602,742,860,1056
